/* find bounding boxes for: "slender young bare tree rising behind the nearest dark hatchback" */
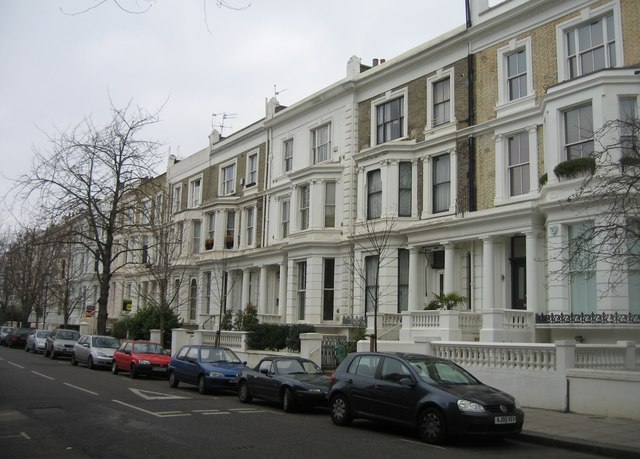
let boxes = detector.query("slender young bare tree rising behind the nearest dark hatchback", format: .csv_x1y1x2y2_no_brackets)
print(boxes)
349,218,396,351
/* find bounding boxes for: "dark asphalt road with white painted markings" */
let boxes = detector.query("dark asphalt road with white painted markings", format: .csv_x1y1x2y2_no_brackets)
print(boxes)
0,347,596,459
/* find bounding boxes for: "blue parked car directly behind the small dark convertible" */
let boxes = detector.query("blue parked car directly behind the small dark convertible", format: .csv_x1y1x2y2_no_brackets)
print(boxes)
169,345,247,394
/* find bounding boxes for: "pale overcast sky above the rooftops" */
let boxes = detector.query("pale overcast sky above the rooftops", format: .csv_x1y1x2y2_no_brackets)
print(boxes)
0,0,465,228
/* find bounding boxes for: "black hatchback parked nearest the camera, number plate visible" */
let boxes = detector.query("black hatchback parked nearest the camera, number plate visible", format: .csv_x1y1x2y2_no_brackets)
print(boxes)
329,352,524,443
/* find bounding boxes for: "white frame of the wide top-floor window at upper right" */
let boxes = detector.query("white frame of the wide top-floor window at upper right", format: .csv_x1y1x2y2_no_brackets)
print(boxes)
556,0,624,81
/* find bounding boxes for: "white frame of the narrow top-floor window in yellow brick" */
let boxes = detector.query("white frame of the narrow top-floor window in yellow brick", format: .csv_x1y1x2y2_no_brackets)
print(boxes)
496,37,535,111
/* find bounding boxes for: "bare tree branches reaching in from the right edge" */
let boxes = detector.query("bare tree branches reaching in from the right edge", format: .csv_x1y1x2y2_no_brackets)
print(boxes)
552,116,640,294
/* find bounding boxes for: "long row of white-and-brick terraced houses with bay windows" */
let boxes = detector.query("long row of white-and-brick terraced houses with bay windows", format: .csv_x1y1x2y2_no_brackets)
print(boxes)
76,0,640,343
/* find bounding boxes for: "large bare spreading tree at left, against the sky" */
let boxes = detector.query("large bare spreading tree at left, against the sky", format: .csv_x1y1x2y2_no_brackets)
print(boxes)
18,104,159,333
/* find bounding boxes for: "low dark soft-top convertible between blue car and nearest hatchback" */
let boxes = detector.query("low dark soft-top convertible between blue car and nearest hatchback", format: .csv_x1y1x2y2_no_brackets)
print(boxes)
238,357,329,412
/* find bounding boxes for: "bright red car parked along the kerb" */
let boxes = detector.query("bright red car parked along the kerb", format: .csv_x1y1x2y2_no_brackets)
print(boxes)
111,341,171,379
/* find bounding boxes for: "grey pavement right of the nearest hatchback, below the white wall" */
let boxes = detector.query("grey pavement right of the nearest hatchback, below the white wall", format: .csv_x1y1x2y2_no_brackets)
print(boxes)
516,408,640,458
